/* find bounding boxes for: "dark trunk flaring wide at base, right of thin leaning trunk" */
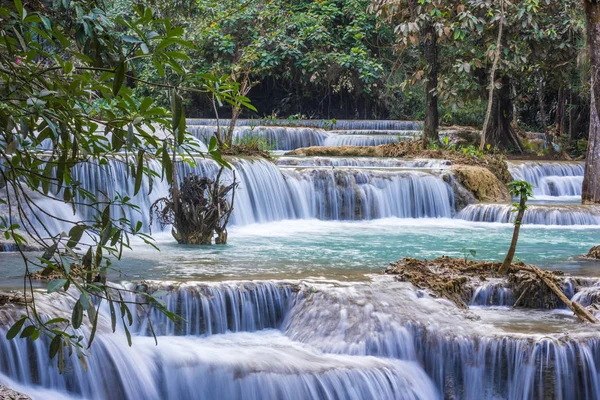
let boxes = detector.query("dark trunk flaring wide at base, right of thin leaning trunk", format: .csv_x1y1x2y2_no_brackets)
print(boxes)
481,75,524,153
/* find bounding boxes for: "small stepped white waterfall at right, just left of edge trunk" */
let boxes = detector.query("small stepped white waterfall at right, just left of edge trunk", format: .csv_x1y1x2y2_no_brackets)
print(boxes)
508,162,584,198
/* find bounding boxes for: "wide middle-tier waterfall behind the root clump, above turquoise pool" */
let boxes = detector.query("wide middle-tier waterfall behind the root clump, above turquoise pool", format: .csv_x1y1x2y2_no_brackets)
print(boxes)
18,158,454,233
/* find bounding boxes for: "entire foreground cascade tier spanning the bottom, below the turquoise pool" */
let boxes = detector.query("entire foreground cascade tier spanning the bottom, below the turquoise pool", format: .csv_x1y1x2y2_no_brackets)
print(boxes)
0,277,600,400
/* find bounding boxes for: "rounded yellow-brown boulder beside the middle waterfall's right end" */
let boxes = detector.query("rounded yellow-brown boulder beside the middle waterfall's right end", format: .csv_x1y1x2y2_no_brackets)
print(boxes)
452,165,510,202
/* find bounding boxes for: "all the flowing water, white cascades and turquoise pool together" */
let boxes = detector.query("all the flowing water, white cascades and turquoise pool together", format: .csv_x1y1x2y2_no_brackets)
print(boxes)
0,120,600,400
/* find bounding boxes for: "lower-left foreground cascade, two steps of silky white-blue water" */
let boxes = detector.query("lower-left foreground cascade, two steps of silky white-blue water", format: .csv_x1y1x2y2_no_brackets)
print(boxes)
0,282,440,399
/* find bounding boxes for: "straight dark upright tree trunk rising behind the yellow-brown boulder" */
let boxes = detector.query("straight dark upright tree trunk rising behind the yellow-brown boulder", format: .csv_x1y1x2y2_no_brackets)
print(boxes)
423,24,440,147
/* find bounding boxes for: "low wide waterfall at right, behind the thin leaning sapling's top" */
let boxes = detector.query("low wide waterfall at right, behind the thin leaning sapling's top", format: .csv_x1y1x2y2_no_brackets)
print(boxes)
456,204,600,226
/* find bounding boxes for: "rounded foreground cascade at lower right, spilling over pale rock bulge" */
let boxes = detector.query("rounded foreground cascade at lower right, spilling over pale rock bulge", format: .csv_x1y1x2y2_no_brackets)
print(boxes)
284,283,600,400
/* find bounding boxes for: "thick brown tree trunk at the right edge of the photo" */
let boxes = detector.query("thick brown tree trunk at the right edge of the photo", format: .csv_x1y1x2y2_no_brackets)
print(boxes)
581,0,600,204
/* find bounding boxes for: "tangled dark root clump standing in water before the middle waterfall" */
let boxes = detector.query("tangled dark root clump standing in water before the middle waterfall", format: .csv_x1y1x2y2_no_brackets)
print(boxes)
150,168,238,244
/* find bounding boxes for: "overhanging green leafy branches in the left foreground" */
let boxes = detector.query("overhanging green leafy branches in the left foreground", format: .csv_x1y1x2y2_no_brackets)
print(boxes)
0,1,252,369
